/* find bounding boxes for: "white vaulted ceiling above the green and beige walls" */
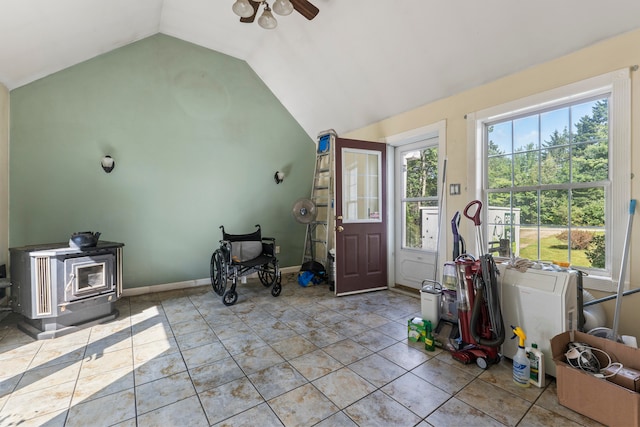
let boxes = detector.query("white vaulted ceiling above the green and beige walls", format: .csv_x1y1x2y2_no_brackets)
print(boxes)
0,0,640,138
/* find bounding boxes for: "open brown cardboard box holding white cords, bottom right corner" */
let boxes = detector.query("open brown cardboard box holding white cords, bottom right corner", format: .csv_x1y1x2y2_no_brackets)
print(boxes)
551,331,640,427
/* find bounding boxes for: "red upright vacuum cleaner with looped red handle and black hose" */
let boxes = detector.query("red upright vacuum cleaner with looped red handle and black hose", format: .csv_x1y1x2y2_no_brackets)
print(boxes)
451,200,505,369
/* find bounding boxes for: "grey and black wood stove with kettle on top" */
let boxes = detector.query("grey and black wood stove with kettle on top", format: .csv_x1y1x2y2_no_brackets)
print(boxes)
9,241,124,339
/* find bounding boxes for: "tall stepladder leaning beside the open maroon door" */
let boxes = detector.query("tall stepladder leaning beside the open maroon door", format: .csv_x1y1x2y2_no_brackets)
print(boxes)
302,129,337,270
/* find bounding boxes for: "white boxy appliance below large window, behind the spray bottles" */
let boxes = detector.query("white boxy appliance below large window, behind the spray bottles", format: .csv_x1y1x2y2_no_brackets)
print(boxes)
498,265,578,377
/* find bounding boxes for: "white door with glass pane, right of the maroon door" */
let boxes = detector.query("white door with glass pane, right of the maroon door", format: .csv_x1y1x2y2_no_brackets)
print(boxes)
394,136,445,289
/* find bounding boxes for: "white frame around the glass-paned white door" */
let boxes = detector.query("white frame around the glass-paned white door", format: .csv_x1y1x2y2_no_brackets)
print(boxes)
384,120,447,287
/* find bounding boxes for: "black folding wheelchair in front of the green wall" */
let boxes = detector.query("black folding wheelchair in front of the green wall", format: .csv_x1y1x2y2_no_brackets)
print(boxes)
211,224,282,306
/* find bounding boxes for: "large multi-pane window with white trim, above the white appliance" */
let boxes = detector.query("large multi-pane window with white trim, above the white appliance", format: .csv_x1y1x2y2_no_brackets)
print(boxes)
470,70,630,290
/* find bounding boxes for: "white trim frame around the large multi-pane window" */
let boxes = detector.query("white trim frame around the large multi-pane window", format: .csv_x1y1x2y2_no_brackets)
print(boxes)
466,68,631,292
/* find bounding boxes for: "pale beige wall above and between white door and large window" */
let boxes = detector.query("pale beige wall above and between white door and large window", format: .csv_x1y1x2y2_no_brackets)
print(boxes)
341,31,640,337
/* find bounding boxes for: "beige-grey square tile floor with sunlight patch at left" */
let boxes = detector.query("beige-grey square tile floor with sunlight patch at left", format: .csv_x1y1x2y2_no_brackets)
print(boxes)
0,275,599,427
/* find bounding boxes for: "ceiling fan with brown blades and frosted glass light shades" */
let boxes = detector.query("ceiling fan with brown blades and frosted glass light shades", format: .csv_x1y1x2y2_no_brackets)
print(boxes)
232,0,320,30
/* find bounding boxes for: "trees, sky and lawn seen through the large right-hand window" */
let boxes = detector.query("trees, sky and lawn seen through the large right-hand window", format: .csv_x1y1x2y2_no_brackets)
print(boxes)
485,96,609,268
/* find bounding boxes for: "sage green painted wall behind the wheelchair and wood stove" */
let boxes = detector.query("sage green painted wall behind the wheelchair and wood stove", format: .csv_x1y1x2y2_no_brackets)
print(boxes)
9,35,315,288
